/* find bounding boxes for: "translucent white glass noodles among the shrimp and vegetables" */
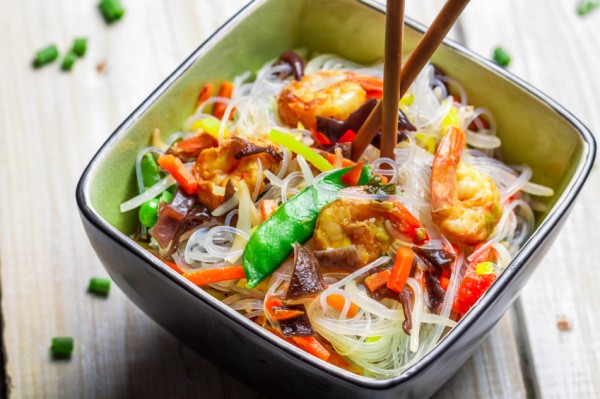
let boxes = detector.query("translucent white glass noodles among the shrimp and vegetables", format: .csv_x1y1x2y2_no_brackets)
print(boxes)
121,54,554,378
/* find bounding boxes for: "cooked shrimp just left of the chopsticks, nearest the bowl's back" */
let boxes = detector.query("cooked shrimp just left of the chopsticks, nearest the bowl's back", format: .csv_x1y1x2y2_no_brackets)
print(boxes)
277,71,383,129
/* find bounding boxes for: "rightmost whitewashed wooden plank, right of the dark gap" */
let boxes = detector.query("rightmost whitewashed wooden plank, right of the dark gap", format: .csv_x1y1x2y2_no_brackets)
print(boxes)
463,0,600,398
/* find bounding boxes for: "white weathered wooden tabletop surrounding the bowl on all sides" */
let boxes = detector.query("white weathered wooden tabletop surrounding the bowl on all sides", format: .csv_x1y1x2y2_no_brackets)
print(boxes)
0,0,600,398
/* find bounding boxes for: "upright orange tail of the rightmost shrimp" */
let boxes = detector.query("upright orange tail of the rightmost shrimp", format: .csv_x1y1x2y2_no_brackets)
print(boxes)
431,126,466,213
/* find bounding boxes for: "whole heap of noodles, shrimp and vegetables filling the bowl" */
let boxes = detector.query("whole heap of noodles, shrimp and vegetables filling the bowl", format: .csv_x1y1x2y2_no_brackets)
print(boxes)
121,50,553,378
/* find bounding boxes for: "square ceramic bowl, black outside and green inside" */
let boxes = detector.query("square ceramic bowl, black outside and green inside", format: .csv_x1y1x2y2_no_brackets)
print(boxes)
76,0,595,398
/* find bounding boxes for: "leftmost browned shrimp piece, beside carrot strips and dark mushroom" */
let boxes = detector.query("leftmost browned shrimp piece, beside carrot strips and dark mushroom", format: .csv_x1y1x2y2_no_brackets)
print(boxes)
192,137,282,211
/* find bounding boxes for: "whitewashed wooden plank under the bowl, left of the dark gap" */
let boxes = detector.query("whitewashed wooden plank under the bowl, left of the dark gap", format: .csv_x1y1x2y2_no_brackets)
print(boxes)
0,0,524,398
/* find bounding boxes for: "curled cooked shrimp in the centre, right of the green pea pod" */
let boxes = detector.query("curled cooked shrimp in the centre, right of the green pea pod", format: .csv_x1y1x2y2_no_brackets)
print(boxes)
313,195,429,265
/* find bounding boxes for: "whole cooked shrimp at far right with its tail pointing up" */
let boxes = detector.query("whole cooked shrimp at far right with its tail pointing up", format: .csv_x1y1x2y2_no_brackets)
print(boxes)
431,127,502,245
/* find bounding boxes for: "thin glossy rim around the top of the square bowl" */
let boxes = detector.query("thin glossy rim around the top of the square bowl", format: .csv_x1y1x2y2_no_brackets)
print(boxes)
75,0,596,390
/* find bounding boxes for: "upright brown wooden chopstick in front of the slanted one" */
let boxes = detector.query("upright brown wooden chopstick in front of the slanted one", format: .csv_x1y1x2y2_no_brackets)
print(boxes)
380,0,404,159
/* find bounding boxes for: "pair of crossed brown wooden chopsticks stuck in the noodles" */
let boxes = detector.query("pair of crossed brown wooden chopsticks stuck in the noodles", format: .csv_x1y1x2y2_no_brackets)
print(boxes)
352,0,469,161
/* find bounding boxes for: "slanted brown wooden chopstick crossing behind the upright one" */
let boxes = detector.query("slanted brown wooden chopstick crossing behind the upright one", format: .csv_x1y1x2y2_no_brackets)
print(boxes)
351,0,469,161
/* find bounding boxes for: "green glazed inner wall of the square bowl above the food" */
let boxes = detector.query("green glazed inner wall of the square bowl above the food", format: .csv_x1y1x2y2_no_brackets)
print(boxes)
82,0,595,390
